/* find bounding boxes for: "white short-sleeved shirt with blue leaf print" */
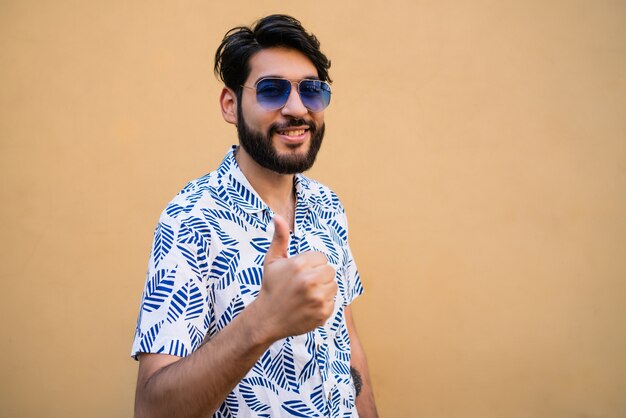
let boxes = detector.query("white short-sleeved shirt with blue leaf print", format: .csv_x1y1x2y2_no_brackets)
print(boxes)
132,147,363,418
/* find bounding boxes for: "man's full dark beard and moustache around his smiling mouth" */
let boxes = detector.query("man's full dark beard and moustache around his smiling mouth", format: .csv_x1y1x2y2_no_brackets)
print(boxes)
237,107,326,174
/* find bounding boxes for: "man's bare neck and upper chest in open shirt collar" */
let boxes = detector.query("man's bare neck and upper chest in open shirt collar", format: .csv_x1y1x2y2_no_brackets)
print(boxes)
235,147,295,230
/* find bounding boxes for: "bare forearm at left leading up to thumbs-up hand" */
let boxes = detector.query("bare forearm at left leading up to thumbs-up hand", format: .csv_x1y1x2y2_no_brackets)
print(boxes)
135,303,272,418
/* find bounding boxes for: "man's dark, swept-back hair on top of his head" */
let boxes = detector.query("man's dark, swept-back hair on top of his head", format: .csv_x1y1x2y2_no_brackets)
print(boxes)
213,14,332,92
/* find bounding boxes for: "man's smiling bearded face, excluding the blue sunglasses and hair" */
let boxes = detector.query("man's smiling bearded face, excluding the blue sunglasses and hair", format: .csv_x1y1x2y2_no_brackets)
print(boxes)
237,48,324,174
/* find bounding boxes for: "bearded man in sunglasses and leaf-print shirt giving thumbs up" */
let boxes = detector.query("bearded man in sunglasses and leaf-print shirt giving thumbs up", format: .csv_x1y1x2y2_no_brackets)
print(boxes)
133,15,377,418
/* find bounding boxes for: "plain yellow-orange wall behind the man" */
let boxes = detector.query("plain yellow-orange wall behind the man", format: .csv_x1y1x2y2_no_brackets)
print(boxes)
0,0,626,418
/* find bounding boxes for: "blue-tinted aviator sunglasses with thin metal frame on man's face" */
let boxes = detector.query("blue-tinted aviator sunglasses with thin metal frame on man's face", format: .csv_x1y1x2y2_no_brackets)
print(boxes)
241,78,331,112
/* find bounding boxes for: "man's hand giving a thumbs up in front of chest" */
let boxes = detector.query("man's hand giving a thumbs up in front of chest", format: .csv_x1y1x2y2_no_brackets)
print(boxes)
255,215,337,340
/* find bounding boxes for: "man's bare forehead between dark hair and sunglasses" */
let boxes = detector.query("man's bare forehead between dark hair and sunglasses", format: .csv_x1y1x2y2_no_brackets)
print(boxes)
247,48,318,84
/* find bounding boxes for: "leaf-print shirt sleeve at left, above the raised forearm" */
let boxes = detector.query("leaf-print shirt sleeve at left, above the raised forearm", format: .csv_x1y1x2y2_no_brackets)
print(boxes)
131,211,211,358
